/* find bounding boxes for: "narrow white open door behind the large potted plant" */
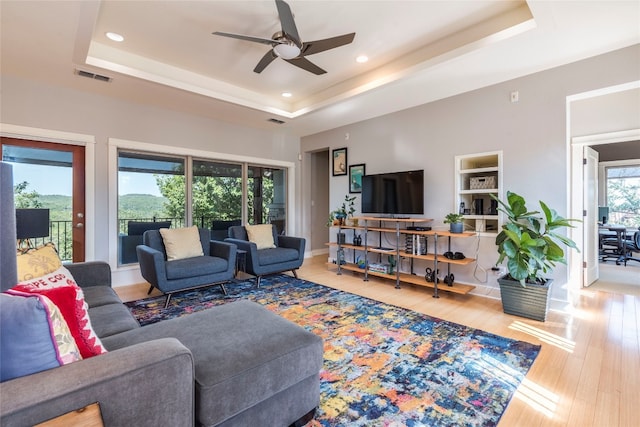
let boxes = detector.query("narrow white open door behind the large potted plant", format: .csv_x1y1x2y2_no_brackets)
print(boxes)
582,146,600,286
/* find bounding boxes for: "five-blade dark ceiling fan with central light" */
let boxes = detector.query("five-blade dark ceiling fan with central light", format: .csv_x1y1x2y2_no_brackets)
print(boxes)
213,0,356,75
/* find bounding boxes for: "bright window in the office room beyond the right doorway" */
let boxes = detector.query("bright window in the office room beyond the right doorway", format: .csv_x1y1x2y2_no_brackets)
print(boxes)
605,163,640,228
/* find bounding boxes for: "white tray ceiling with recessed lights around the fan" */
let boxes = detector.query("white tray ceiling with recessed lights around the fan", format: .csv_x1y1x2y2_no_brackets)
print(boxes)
0,0,640,136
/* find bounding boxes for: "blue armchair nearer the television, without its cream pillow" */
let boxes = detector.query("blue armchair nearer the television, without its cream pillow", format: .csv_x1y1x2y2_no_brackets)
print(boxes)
224,225,306,287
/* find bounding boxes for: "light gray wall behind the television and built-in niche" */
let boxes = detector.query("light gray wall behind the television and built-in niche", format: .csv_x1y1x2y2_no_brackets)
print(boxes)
301,46,640,301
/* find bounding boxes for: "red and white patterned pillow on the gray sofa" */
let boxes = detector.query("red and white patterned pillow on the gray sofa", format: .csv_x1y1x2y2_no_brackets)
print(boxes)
7,267,107,359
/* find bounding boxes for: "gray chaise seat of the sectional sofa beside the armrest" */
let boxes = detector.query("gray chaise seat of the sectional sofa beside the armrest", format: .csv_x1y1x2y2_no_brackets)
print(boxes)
104,300,323,426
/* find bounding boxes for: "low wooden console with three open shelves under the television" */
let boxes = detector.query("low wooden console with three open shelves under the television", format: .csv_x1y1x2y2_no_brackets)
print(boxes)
328,217,476,298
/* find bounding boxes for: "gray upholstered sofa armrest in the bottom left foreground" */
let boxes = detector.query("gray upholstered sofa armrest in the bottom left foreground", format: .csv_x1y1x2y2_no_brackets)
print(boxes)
0,338,194,427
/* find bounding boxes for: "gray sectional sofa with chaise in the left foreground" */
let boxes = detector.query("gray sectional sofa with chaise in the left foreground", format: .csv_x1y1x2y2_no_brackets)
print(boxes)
0,262,323,427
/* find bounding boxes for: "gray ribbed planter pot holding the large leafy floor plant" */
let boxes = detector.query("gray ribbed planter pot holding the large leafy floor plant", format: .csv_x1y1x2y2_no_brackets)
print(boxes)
498,276,553,322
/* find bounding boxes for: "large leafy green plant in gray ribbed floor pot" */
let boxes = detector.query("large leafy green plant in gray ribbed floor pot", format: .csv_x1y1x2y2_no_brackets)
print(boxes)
492,191,578,322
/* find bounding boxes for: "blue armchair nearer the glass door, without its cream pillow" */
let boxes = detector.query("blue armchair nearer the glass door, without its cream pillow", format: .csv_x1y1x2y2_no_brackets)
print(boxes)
136,228,237,307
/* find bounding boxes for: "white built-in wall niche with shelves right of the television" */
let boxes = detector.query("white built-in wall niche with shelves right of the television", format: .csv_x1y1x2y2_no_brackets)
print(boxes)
454,151,502,235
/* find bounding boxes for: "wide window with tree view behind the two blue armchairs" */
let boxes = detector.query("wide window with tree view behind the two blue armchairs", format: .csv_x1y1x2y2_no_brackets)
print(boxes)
117,149,287,265
